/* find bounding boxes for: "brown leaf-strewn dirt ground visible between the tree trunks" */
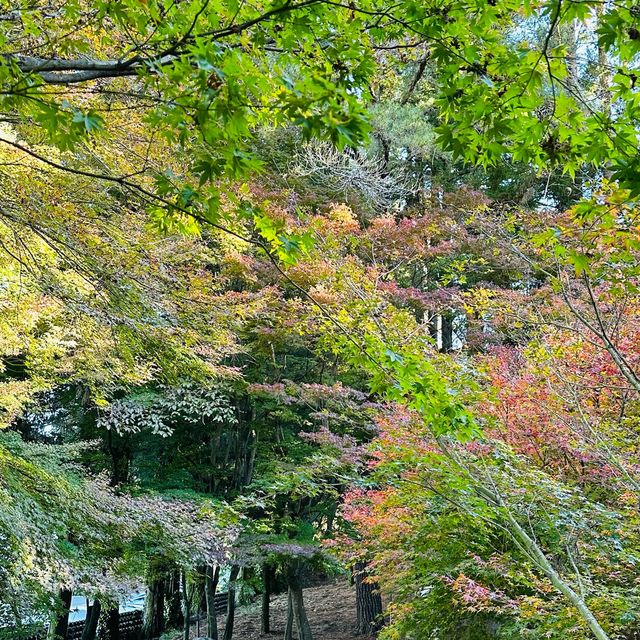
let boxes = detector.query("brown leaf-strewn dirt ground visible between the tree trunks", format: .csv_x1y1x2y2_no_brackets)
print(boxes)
177,580,367,640
